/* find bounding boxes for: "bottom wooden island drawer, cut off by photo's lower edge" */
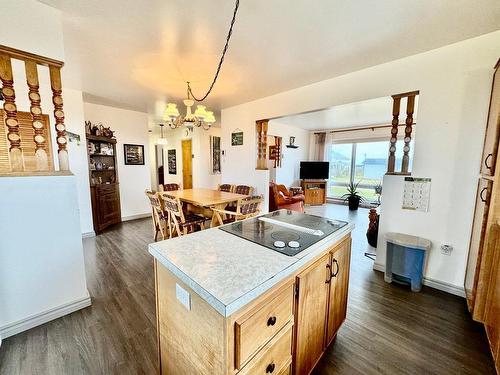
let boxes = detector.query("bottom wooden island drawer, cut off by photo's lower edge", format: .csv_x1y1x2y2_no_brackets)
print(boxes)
239,322,293,375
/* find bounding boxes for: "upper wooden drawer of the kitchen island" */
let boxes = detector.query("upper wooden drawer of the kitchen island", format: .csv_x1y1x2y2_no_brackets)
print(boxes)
234,284,293,369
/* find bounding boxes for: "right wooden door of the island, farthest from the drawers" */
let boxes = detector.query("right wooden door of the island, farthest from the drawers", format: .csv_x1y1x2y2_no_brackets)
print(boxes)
326,238,351,346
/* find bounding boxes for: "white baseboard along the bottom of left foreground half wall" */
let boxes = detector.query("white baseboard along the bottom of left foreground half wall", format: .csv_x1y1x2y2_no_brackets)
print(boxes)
0,292,92,345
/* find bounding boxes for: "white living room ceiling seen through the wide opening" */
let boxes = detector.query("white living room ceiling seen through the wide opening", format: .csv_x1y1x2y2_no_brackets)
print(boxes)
271,96,418,130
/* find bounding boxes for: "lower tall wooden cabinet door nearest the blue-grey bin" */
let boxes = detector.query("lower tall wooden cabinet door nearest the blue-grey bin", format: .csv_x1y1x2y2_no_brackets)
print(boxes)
464,179,492,312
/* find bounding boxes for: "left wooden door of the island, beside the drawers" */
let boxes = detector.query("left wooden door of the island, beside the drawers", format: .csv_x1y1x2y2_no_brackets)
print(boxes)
294,254,330,375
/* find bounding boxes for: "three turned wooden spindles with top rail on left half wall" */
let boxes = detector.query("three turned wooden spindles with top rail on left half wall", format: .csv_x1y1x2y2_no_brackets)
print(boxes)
0,45,69,172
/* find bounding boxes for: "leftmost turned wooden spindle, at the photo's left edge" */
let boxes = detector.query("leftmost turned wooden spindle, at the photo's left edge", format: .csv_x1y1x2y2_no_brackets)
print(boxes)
0,52,24,172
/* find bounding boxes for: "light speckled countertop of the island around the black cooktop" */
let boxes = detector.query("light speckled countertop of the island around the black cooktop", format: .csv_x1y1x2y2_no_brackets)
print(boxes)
149,217,354,316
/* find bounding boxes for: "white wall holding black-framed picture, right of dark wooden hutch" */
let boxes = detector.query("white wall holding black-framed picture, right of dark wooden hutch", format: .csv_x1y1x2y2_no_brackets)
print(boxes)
84,103,151,220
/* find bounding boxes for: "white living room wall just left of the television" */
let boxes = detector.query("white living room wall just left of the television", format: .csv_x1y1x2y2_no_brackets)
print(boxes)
268,119,310,188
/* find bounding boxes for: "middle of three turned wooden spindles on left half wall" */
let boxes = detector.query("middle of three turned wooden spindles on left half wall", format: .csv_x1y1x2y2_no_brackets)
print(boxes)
24,60,49,171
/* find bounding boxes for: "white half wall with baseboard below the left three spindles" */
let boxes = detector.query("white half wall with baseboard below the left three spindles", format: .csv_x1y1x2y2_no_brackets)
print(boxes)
0,176,90,341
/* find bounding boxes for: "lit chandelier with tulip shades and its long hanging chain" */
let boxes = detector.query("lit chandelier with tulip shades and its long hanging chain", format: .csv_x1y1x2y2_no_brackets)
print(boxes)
163,0,240,130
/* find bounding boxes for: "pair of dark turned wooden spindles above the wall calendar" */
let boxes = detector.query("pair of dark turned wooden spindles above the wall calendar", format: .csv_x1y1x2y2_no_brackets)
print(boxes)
387,91,419,175
